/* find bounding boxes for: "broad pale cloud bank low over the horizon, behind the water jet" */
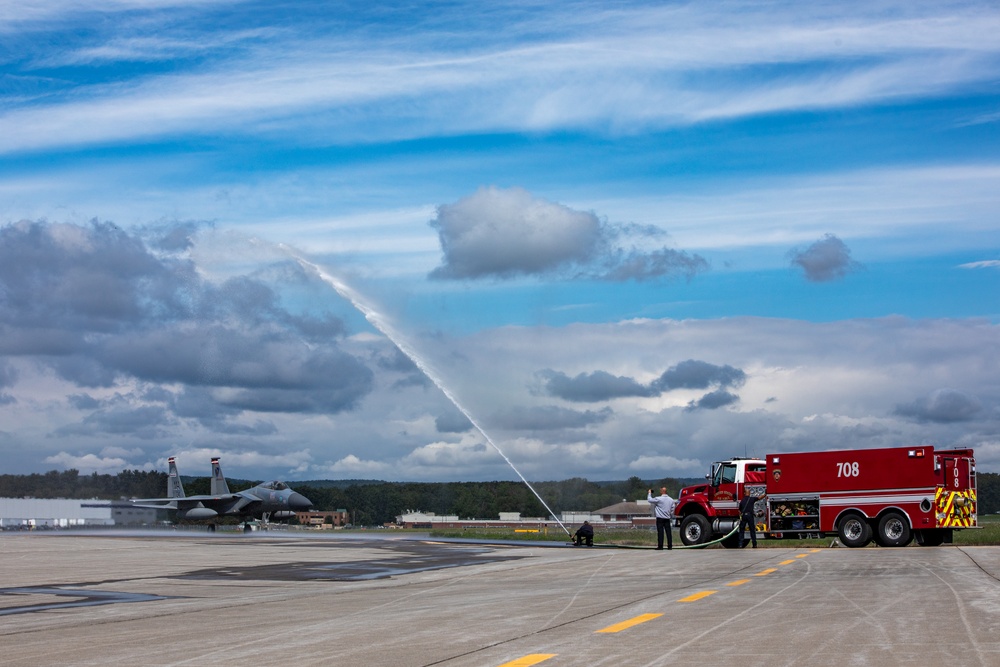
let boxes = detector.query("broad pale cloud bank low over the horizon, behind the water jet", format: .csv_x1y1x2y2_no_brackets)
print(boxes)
11,318,1000,481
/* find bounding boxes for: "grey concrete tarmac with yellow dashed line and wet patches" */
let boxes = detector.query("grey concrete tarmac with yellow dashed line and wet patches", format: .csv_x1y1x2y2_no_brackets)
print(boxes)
0,531,1000,667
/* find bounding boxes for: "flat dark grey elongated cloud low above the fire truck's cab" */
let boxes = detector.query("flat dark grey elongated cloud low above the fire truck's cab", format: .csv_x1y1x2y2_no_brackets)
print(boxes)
538,359,746,409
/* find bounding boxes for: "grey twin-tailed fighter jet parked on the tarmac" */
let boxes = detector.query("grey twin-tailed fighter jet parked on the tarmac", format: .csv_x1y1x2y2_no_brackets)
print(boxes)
129,456,312,531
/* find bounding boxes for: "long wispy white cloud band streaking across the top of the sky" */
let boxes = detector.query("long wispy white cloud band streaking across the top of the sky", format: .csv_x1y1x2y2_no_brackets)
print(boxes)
0,3,1000,151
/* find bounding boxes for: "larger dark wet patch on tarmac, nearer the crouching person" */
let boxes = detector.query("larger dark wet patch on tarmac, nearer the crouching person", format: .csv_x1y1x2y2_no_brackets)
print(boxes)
183,543,522,581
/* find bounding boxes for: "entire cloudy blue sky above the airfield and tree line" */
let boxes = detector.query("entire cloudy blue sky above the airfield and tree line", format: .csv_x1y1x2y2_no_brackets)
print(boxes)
0,0,1000,488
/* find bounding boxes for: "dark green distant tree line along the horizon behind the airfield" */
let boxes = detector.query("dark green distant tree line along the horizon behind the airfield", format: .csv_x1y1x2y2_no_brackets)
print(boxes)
0,470,1000,525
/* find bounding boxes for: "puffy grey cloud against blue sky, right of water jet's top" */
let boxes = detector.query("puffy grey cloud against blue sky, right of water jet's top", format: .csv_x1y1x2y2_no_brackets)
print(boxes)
430,186,708,282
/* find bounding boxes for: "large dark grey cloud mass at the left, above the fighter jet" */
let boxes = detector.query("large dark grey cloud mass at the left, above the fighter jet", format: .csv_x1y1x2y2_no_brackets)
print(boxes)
0,221,373,438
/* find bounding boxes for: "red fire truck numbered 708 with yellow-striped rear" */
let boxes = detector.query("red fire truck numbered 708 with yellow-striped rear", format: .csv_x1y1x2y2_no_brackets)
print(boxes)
674,446,976,548
